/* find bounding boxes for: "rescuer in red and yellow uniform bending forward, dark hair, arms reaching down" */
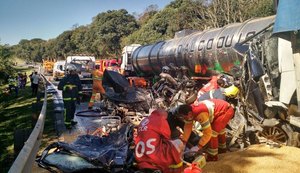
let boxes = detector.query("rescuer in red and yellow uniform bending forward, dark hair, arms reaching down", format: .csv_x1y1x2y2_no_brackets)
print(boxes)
176,99,234,161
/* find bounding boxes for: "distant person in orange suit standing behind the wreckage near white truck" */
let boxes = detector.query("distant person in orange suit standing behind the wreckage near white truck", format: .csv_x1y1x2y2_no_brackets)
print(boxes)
88,65,105,109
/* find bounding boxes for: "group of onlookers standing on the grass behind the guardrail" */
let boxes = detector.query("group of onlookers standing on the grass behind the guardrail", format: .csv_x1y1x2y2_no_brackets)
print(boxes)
4,71,40,97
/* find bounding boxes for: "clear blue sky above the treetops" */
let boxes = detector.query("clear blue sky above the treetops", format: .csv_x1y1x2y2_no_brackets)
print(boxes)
0,0,173,45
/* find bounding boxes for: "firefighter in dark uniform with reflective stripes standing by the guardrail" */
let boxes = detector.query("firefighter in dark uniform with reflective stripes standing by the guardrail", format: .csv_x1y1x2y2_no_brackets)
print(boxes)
57,64,82,128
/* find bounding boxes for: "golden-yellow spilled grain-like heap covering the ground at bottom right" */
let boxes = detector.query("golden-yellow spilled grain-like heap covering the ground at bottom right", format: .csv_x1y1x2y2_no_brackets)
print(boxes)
203,144,300,173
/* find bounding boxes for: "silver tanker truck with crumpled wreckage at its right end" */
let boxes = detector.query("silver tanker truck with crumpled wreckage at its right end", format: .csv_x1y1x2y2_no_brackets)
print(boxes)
122,16,300,145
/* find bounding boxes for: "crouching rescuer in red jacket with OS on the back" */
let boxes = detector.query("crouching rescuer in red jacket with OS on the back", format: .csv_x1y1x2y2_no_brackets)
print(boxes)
135,109,184,173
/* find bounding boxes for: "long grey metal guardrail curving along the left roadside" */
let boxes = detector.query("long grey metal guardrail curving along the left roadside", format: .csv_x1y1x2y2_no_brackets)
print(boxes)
9,75,47,173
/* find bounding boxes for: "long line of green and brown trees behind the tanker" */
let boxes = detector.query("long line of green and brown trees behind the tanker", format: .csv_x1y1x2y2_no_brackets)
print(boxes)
0,0,275,81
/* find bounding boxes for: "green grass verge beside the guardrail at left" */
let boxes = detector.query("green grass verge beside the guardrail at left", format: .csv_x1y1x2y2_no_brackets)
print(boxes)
0,68,56,172
